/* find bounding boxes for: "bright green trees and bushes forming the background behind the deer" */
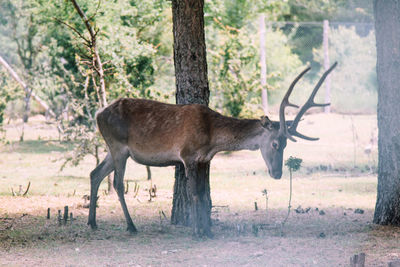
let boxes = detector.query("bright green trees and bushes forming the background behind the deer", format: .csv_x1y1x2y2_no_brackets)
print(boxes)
0,0,377,168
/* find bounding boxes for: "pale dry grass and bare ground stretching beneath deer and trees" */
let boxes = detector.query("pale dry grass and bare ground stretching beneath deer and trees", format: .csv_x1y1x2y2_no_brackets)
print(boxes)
0,114,400,266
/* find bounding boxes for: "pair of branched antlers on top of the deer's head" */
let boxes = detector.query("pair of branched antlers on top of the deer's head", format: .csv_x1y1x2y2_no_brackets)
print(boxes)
279,62,337,142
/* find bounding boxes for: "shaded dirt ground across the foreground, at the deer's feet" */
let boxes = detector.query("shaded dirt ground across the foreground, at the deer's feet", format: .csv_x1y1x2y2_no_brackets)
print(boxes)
0,196,400,266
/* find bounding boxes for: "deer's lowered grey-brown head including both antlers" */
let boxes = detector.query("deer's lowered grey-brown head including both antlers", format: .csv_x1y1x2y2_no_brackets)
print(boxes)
260,62,337,179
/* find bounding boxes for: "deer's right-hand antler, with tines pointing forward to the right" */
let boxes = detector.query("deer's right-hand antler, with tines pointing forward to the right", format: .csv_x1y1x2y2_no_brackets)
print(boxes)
288,62,337,141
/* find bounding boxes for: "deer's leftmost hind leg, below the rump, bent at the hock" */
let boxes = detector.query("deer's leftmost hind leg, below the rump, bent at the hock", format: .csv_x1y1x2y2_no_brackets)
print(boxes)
88,153,114,229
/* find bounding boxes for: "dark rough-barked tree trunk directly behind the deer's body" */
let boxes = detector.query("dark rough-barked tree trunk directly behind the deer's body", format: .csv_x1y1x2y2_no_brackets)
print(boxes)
171,0,211,228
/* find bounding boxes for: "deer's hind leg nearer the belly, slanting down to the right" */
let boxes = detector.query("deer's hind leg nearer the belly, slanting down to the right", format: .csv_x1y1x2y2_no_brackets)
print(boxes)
113,148,137,233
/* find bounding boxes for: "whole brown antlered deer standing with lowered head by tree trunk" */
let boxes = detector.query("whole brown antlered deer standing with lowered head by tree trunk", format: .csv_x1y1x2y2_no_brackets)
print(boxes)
88,62,337,236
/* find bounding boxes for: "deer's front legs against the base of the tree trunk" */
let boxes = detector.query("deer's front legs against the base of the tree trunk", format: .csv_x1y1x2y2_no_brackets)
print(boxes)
186,164,212,237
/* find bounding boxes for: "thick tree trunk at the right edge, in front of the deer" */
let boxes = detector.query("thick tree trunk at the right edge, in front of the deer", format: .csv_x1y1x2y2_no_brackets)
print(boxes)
374,0,400,225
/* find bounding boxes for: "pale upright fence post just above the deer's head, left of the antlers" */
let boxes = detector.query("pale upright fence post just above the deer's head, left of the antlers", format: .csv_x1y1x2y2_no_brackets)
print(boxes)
259,14,268,115
